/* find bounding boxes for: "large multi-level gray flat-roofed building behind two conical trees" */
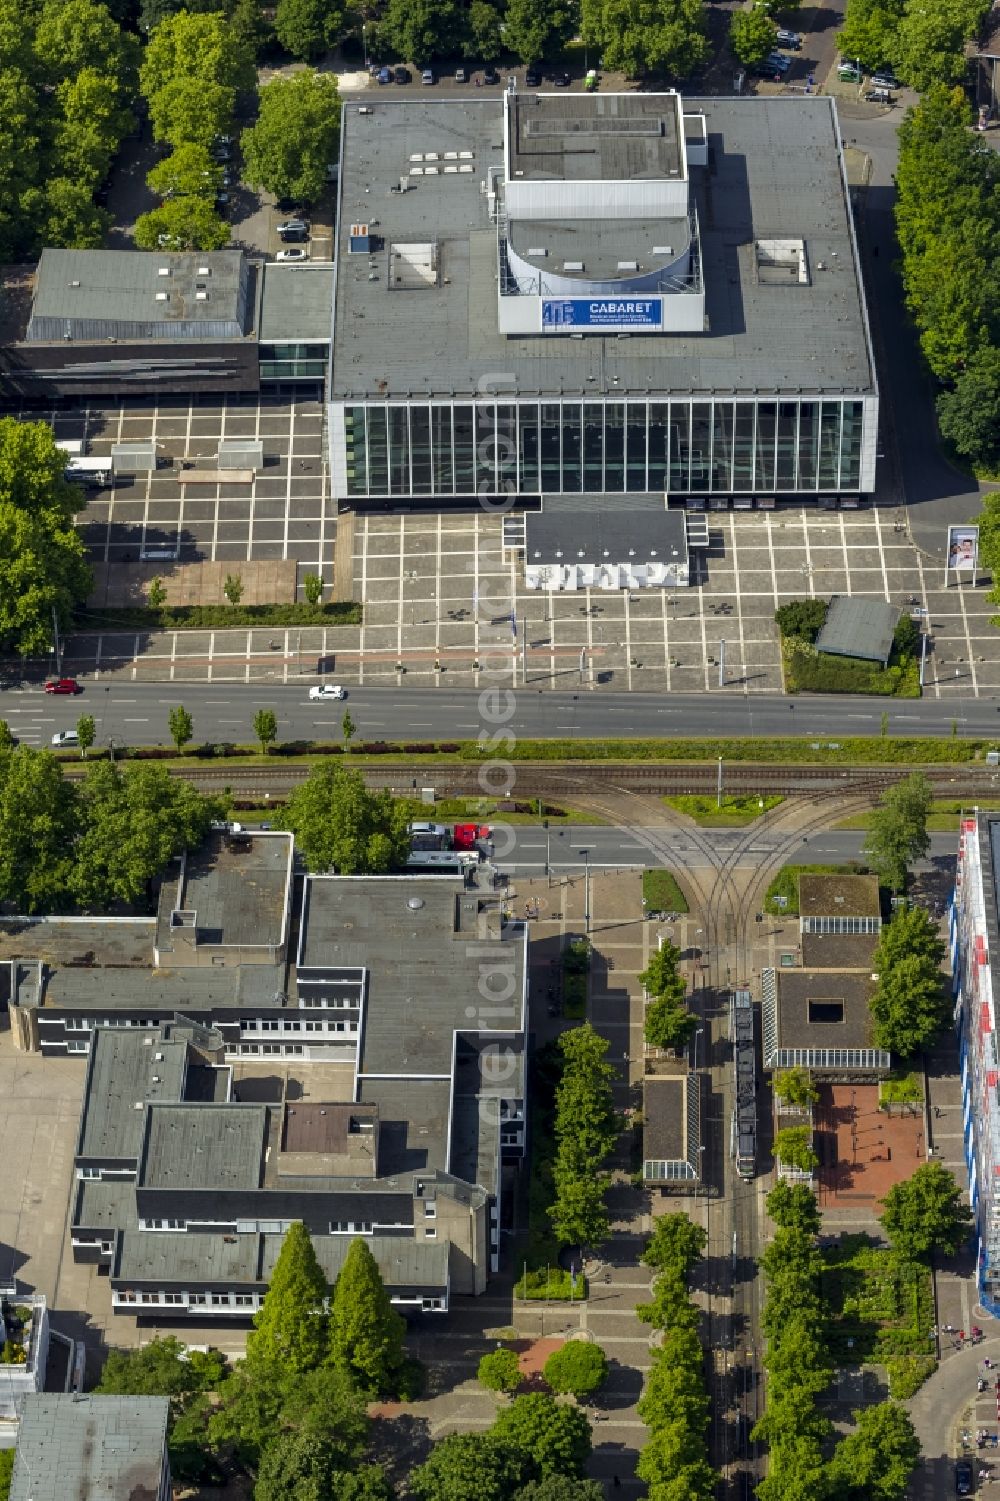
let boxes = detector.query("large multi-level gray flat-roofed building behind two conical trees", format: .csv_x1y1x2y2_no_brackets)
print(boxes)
64,877,527,1319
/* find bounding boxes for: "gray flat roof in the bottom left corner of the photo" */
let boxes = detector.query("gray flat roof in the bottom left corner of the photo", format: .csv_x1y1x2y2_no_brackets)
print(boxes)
11,1393,170,1501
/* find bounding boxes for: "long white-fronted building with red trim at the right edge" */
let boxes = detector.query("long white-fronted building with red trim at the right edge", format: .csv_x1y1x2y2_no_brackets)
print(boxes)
949,812,1000,1318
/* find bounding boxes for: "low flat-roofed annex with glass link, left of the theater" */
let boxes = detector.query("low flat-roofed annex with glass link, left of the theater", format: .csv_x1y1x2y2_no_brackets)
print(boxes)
0,249,333,401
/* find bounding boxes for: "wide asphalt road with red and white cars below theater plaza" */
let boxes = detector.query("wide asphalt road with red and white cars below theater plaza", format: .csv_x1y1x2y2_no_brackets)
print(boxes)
7,680,1000,757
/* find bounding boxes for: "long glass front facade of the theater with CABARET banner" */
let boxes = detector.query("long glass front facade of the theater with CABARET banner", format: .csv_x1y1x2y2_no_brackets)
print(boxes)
333,396,874,498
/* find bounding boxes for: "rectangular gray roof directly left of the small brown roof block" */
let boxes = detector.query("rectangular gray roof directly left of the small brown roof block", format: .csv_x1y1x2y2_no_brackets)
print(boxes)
137,1103,269,1189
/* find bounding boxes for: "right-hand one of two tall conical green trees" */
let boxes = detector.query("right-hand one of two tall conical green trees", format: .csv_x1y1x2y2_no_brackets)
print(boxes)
330,1240,405,1396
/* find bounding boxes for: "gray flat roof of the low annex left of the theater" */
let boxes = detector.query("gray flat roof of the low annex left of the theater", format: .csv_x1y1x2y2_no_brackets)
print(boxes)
27,249,254,344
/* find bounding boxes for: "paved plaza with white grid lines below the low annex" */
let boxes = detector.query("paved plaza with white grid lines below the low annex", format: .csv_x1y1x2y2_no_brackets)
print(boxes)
3,396,335,572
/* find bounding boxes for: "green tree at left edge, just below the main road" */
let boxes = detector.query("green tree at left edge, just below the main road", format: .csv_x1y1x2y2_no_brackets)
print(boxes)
0,746,78,913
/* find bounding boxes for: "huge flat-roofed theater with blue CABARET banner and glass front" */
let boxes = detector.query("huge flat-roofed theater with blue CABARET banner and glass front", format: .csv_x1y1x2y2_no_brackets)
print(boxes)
329,90,878,509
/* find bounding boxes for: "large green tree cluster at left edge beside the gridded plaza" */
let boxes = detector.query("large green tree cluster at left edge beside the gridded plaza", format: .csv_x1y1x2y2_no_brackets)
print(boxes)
0,420,92,656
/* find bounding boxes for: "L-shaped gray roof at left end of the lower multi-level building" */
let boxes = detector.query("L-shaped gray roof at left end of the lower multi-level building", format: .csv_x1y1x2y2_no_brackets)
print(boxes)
77,1027,188,1159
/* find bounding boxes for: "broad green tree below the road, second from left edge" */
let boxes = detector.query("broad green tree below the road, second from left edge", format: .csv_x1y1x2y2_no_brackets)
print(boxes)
68,761,225,907
